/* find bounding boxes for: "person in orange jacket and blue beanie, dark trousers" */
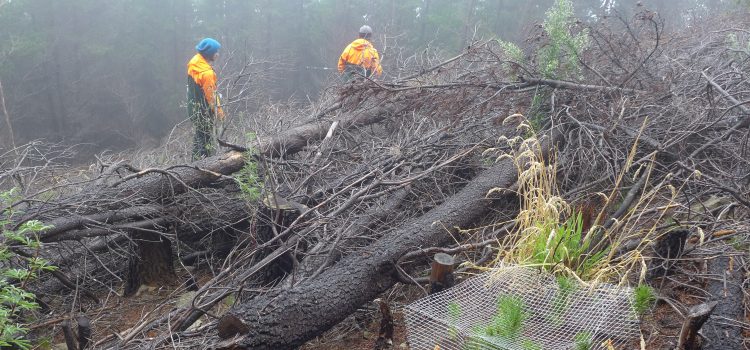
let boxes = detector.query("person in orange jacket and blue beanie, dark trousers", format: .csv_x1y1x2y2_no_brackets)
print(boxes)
187,38,224,160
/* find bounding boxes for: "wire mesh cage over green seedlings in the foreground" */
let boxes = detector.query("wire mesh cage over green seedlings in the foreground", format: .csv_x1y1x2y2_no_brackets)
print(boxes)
405,266,639,350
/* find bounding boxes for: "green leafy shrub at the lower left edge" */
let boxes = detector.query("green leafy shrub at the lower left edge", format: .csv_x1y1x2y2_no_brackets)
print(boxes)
0,190,56,349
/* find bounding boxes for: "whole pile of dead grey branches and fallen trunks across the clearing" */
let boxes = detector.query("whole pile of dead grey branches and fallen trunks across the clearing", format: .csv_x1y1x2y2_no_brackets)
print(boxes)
0,11,750,349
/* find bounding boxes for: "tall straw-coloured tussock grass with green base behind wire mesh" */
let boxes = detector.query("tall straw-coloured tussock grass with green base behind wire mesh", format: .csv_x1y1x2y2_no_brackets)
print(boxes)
485,114,699,286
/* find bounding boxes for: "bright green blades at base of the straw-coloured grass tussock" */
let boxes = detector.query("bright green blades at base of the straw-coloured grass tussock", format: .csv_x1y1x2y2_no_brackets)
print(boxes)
531,212,607,278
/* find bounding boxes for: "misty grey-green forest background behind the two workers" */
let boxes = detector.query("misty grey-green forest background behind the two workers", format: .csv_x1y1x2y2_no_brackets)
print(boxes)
0,0,748,161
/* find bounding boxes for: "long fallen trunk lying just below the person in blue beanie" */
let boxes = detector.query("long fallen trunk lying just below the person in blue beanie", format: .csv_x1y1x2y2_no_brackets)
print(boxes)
25,98,408,242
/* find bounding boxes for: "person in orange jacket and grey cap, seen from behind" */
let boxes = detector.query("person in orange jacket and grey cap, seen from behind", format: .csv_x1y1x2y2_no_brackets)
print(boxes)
338,25,383,82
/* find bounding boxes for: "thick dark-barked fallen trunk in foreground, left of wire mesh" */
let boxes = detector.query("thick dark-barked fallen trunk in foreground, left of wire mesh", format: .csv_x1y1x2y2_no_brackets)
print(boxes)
214,153,528,349
